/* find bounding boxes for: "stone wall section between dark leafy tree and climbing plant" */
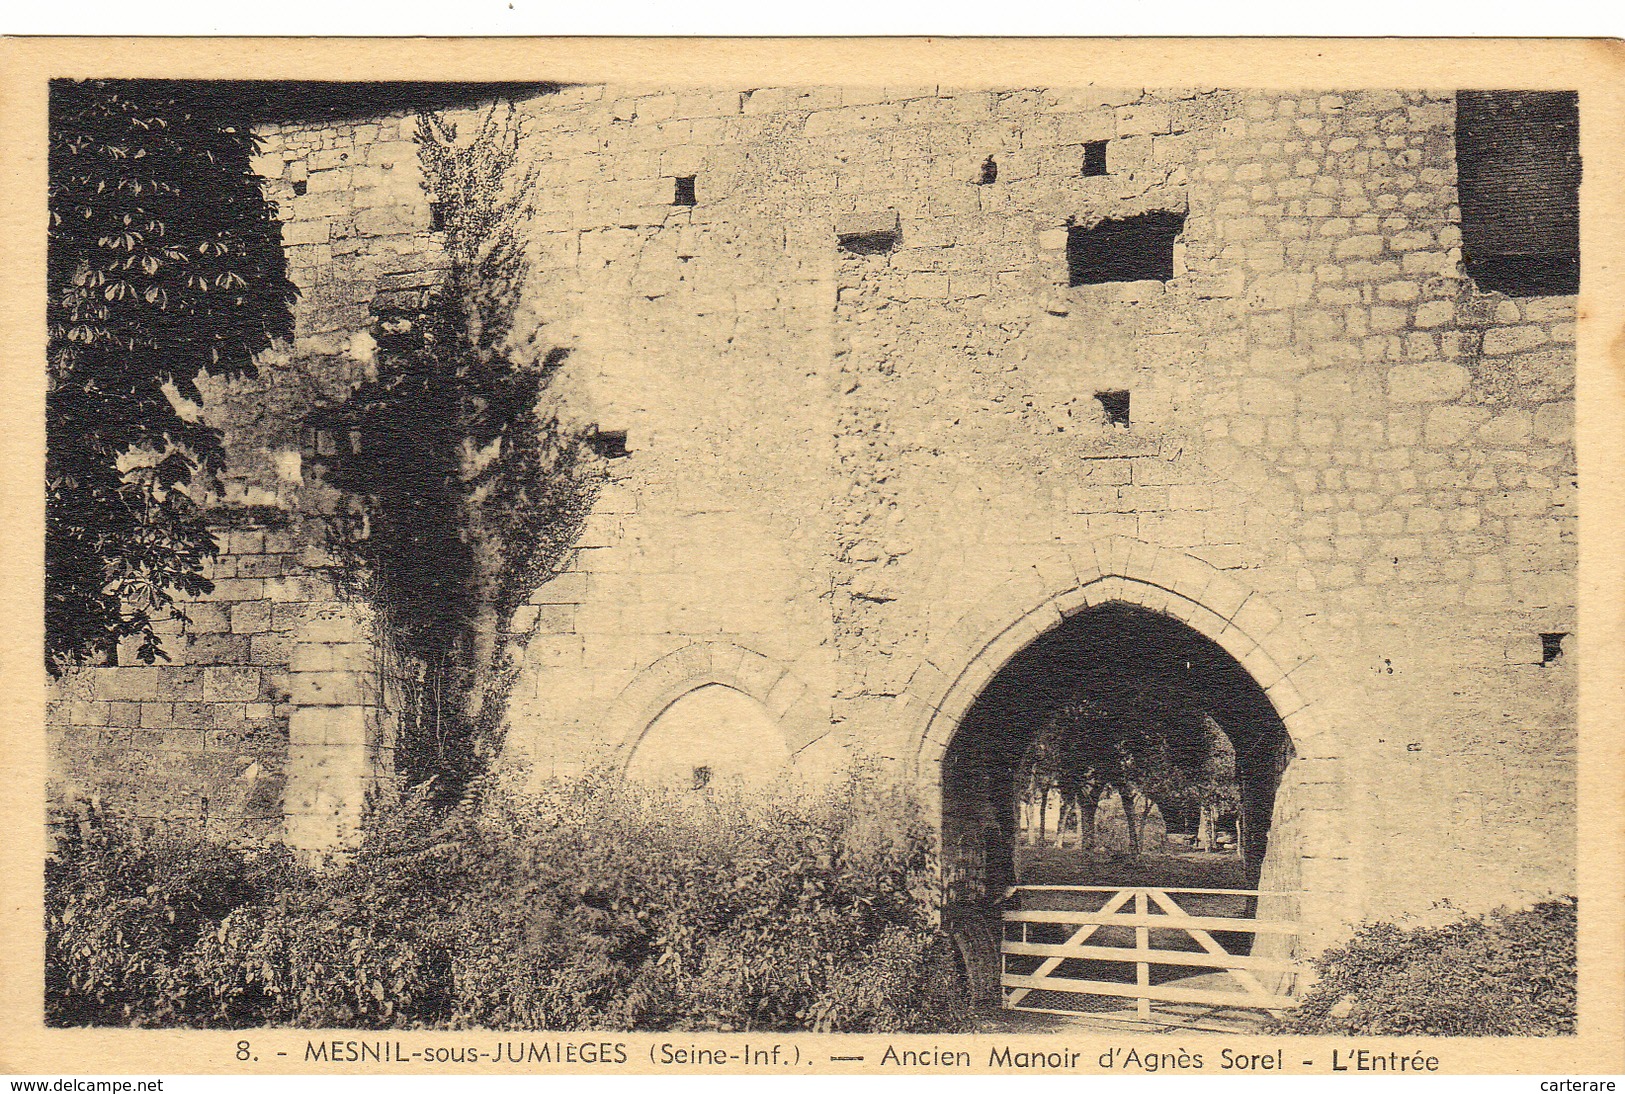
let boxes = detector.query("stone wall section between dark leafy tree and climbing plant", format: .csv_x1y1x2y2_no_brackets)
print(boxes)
47,115,439,850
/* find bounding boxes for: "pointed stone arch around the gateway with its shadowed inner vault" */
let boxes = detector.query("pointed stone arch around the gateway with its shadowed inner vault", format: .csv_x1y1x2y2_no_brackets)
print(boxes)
908,536,1347,993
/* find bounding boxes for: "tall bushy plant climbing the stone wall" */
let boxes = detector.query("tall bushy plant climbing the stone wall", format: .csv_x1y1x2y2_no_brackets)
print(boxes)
316,107,598,790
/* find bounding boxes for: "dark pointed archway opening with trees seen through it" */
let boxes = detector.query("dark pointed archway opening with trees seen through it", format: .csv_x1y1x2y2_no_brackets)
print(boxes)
941,601,1295,1007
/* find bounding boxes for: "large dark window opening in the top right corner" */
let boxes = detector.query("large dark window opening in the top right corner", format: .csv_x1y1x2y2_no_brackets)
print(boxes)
1456,91,1580,296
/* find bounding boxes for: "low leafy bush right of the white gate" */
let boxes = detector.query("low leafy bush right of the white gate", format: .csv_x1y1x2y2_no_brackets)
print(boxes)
1284,897,1578,1037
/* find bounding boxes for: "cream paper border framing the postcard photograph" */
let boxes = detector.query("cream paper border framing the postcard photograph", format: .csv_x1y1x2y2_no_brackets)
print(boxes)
0,37,1625,1074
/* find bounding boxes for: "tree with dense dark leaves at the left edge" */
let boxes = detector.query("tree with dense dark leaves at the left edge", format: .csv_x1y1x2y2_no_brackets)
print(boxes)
46,80,297,673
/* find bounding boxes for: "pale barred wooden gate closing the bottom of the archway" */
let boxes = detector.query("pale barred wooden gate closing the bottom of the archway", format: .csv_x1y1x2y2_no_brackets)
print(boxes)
1001,886,1298,1024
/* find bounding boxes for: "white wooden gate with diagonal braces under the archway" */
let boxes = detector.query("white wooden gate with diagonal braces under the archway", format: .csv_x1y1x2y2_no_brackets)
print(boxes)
999,886,1298,1026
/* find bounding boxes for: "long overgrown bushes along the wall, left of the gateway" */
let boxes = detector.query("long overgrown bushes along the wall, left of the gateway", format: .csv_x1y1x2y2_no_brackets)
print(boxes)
47,764,967,1032
